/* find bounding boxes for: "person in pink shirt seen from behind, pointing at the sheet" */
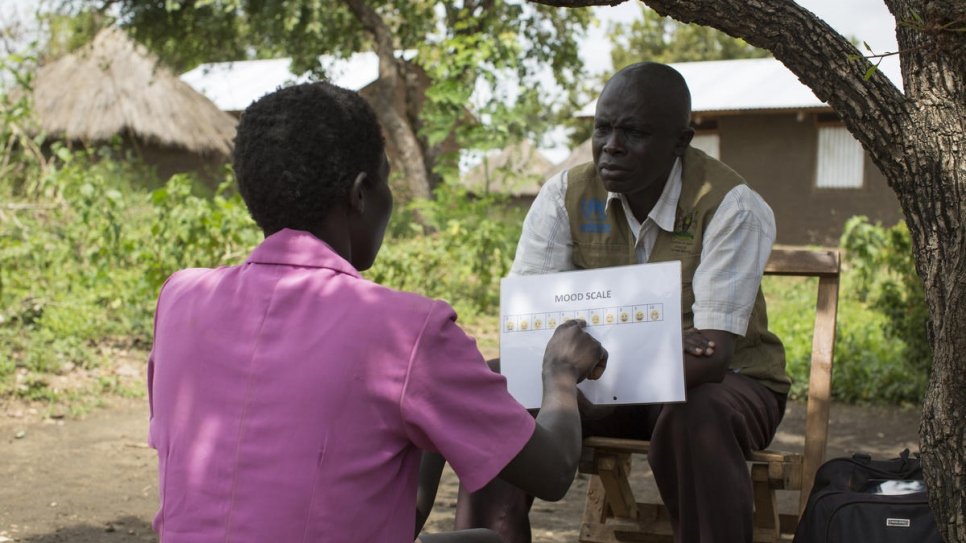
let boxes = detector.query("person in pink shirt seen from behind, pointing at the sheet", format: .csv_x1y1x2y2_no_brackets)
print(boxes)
148,83,607,543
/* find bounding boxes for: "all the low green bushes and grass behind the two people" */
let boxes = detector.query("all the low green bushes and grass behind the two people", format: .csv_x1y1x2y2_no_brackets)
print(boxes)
0,138,931,404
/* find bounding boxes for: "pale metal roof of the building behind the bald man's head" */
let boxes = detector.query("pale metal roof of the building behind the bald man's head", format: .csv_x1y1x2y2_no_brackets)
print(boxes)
575,58,902,117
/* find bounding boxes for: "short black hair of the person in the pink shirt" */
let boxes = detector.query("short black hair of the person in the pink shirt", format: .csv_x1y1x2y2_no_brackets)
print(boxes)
234,82,385,236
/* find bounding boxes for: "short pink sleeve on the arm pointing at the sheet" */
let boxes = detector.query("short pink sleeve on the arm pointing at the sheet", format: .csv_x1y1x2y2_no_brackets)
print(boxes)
400,302,536,492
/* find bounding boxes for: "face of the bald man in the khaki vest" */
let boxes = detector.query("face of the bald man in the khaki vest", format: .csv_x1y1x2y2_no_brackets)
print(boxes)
591,75,692,196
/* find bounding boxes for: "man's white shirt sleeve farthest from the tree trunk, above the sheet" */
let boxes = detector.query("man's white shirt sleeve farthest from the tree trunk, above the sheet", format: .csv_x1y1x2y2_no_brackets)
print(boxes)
510,170,574,275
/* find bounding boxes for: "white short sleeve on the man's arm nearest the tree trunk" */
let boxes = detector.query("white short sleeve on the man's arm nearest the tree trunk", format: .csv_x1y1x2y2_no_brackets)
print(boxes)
693,185,775,336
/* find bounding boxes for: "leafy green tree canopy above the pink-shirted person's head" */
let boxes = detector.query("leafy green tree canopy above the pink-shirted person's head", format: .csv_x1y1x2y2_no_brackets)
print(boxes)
87,0,592,196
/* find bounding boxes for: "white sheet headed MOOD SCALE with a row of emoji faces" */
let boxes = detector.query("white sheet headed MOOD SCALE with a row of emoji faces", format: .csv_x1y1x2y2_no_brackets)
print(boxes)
500,261,685,409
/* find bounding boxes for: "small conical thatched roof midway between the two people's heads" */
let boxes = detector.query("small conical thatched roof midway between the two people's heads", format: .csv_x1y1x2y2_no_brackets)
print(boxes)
463,140,553,196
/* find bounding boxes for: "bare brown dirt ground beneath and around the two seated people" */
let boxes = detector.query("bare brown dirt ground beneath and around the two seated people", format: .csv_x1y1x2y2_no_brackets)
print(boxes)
0,386,919,543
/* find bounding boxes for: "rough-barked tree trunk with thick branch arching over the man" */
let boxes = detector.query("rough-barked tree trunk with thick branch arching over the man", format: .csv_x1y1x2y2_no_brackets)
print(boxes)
531,0,966,543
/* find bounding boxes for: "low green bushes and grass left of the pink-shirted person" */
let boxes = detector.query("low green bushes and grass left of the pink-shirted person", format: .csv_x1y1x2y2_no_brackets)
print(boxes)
0,146,261,397
